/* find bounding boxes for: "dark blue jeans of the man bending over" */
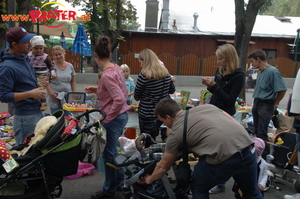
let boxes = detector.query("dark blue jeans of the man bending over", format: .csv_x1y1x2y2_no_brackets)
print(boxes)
192,149,263,199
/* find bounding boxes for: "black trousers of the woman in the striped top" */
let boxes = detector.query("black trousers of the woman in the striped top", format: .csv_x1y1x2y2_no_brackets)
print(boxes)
139,116,162,140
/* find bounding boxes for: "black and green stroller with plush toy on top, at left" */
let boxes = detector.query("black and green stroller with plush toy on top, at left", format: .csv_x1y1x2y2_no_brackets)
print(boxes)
0,109,105,199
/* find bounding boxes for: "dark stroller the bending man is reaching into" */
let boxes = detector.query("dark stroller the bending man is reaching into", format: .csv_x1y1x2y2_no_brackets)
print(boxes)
107,133,190,199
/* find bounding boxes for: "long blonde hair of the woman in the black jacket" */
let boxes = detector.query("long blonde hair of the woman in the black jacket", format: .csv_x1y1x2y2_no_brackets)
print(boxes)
216,44,239,76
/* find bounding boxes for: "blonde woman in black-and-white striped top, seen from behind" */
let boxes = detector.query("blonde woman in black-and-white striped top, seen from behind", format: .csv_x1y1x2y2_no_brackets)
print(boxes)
134,49,175,139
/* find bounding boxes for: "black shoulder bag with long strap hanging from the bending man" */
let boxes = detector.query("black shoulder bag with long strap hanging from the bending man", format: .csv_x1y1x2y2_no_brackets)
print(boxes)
176,110,192,187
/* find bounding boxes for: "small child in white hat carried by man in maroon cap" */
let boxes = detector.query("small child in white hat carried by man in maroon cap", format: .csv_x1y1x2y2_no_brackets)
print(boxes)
28,35,56,111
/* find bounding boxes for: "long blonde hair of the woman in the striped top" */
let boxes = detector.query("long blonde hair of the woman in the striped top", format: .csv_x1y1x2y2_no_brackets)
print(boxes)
139,48,169,80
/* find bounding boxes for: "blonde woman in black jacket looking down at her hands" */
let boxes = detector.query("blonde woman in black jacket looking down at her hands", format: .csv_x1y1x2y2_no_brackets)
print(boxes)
202,44,245,194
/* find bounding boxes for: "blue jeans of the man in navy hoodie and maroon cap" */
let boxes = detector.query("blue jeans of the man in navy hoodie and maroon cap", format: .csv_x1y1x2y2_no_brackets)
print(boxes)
13,112,43,146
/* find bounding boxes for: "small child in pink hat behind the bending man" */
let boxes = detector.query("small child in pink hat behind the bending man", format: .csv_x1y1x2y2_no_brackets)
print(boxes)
233,137,268,199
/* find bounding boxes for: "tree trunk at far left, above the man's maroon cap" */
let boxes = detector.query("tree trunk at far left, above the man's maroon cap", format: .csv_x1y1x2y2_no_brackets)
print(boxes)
16,0,33,32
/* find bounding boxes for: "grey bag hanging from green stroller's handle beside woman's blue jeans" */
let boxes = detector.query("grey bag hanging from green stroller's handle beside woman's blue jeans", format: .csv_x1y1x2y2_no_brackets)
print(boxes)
79,122,106,163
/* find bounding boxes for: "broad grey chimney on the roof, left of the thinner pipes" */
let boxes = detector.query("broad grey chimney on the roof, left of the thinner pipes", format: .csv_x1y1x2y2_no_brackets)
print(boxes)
145,0,158,32
